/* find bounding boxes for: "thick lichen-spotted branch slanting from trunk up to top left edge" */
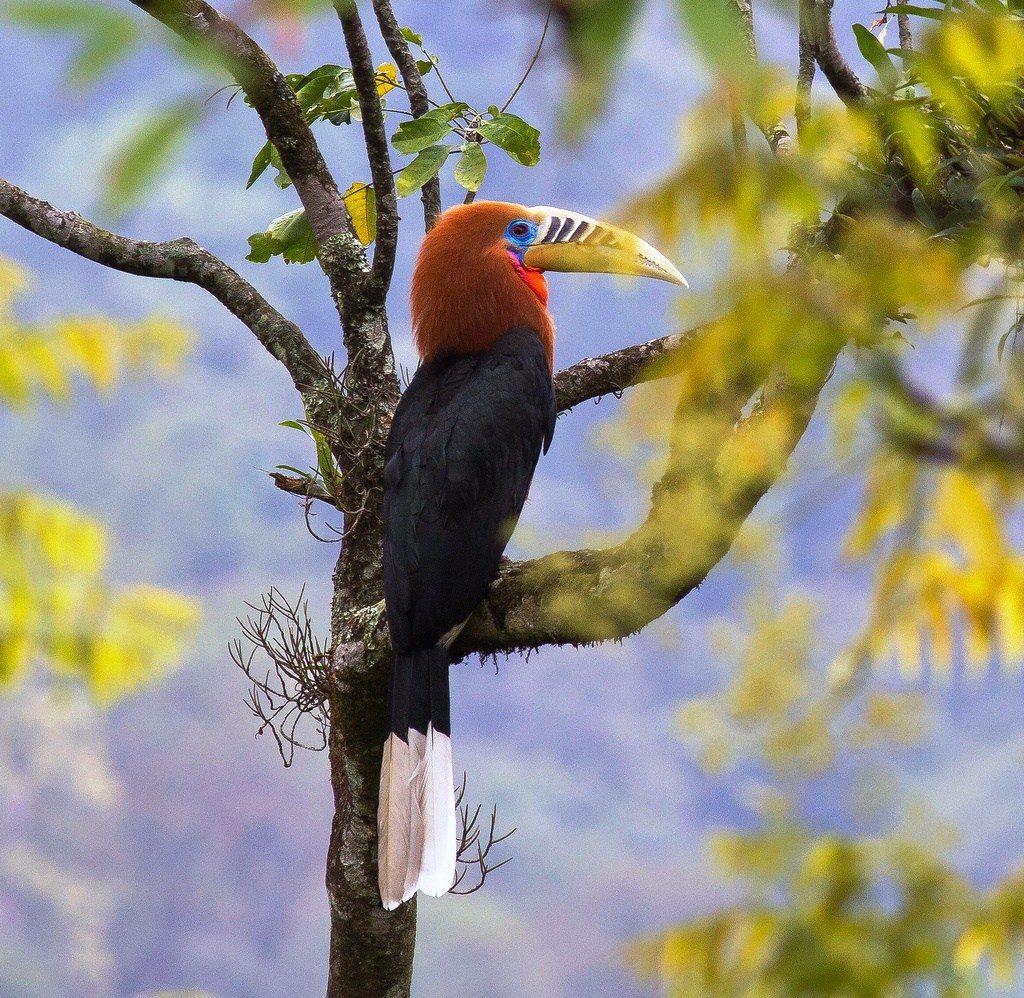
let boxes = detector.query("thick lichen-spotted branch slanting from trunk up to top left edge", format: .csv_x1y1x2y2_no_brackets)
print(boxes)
131,0,368,300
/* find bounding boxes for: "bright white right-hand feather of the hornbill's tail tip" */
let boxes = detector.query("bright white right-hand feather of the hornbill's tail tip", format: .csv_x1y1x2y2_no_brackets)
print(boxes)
415,725,456,898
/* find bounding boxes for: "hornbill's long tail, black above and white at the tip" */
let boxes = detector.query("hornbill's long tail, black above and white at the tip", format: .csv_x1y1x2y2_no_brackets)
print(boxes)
377,645,456,910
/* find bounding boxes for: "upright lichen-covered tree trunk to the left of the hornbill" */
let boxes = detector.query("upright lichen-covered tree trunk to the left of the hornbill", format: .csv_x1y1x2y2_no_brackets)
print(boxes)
327,308,416,998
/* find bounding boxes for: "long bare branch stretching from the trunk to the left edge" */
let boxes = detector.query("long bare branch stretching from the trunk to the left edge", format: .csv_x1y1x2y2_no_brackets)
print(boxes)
0,179,327,392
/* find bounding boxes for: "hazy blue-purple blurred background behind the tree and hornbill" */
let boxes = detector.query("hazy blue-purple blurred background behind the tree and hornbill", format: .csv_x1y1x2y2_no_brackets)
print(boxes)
0,0,1024,998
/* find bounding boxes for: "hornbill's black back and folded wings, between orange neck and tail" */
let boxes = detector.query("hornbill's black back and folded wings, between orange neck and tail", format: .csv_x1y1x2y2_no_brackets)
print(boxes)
384,329,555,652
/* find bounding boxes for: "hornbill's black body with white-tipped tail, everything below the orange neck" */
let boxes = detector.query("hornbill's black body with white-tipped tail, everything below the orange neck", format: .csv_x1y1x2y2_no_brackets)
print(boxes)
379,328,556,908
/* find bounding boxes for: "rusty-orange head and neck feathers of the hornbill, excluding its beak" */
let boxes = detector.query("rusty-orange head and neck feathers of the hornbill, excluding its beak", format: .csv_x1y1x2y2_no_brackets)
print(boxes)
411,202,555,370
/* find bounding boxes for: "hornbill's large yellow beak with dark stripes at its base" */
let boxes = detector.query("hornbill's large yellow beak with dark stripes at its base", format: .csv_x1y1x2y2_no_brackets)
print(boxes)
522,208,689,288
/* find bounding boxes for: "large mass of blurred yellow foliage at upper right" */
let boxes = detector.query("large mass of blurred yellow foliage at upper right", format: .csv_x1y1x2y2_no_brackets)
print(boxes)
602,0,1024,677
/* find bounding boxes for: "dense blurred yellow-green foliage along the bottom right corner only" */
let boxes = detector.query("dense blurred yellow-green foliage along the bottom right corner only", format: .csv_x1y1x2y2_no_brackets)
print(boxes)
631,825,1024,998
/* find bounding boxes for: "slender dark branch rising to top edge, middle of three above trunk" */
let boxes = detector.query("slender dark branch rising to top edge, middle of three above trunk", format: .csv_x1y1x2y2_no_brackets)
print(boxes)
334,0,398,303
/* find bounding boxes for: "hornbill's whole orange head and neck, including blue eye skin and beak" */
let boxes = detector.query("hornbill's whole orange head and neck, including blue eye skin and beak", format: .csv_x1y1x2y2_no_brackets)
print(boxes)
412,201,686,372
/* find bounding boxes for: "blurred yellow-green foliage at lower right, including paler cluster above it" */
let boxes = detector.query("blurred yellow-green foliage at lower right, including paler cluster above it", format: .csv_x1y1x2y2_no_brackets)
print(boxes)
643,576,1024,998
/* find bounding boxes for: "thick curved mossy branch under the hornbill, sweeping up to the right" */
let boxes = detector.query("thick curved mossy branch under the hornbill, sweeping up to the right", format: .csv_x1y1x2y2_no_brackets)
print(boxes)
452,342,843,661
